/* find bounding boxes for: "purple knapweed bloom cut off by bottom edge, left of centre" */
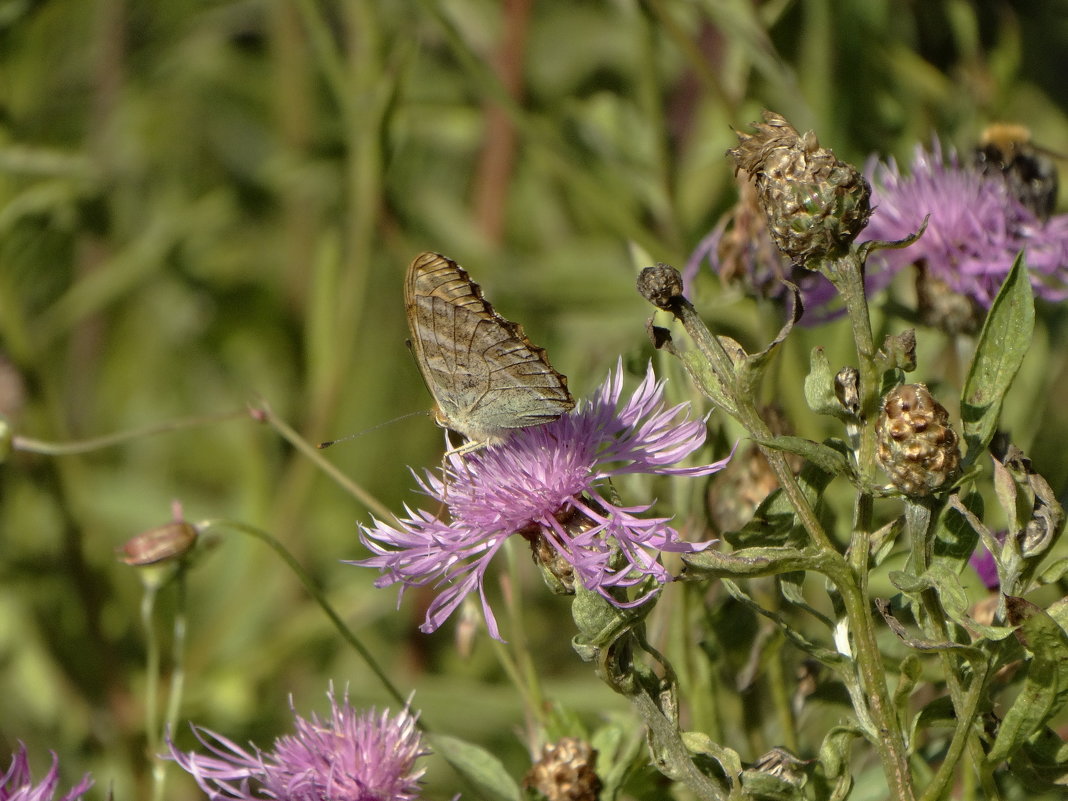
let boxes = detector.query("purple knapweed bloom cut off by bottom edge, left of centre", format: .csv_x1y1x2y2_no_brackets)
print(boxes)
167,688,429,801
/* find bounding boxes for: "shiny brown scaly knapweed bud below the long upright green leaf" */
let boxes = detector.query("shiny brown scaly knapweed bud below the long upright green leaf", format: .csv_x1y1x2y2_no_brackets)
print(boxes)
876,383,960,498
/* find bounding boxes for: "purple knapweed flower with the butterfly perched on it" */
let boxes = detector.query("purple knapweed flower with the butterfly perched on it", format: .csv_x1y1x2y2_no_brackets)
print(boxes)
352,361,729,640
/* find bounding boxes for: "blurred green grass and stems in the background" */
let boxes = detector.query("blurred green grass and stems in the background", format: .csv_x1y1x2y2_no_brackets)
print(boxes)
6,0,1068,799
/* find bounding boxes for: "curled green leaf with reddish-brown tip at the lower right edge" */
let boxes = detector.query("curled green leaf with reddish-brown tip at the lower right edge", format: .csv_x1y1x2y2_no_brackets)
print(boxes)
987,596,1068,765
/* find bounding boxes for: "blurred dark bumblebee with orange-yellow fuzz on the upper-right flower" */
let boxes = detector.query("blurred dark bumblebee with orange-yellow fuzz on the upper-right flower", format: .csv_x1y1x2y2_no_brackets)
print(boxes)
973,123,1057,220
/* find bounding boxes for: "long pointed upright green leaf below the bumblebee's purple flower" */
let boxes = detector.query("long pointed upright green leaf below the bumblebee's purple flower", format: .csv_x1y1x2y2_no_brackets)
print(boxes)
960,254,1035,464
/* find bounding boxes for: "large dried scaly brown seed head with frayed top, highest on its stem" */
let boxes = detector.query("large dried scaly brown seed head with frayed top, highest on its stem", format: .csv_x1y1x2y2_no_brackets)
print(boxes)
727,111,871,269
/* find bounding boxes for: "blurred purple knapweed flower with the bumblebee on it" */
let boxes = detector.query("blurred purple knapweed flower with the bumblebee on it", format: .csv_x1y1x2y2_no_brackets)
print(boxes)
863,140,1068,309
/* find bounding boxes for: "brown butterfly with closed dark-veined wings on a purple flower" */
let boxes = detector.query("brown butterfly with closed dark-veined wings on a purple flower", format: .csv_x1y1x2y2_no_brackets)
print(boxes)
404,253,575,451
